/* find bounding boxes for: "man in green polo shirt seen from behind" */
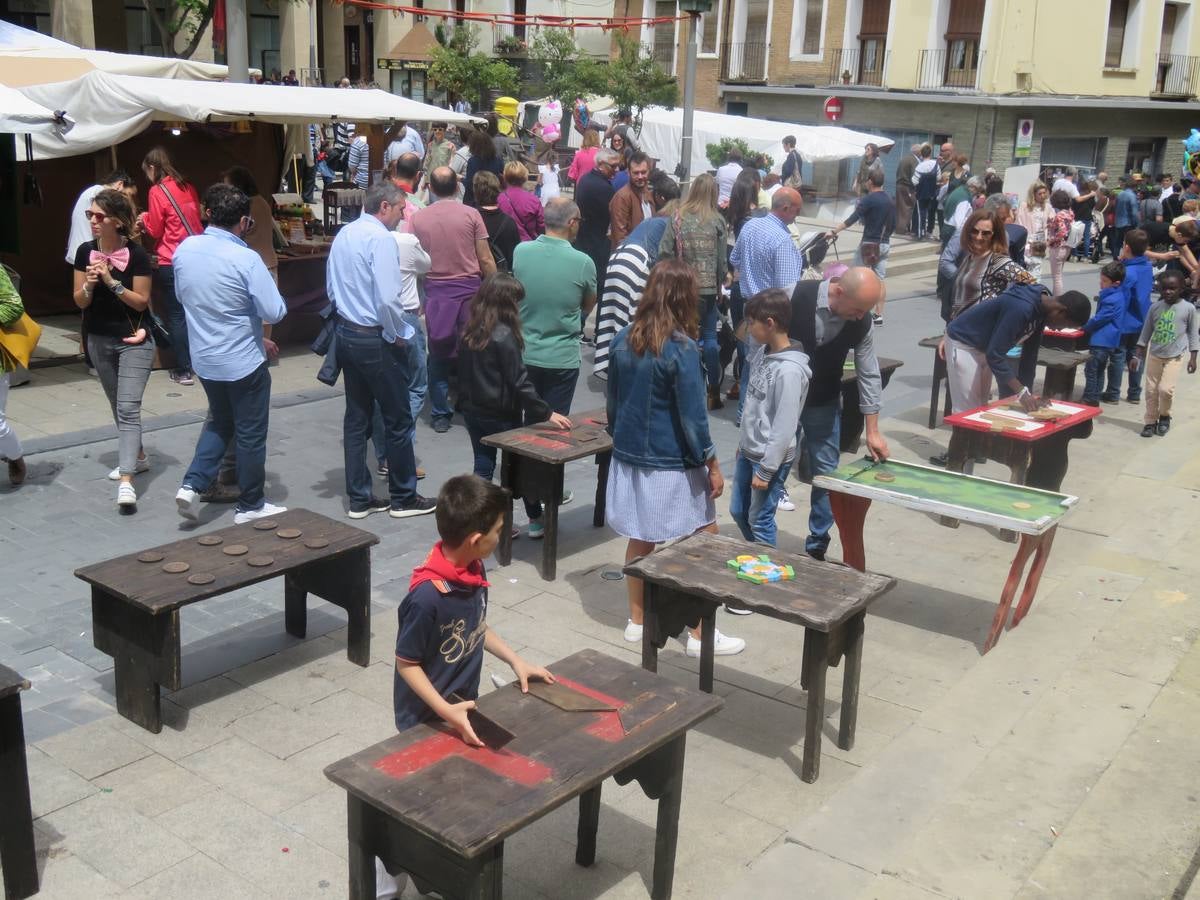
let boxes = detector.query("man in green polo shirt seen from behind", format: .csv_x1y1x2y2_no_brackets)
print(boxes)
512,197,596,415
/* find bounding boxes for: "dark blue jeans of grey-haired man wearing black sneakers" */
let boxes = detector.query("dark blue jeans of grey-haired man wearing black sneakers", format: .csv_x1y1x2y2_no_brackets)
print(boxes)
336,323,416,510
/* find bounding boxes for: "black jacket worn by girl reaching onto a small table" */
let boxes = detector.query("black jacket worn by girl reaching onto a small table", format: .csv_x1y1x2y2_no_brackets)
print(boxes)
458,325,551,422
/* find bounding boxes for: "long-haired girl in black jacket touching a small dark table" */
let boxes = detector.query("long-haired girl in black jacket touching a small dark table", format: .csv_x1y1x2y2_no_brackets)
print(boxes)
458,272,571,534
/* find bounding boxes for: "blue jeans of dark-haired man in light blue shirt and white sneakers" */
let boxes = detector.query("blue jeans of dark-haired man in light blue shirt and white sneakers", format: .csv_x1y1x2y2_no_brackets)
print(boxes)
184,362,271,512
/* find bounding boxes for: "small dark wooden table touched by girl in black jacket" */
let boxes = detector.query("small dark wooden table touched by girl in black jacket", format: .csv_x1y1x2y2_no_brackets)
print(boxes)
482,409,612,581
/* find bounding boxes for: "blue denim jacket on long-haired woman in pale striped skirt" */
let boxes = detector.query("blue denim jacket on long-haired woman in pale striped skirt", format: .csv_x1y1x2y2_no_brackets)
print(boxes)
608,328,715,469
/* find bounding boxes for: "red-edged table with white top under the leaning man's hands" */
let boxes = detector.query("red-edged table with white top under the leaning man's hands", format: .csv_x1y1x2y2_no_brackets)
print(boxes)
946,398,1100,491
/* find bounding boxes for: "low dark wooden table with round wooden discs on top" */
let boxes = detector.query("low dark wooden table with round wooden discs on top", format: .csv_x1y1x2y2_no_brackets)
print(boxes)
76,509,379,734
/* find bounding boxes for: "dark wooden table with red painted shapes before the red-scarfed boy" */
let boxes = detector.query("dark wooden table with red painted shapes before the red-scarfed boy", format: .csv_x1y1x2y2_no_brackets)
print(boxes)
325,650,724,900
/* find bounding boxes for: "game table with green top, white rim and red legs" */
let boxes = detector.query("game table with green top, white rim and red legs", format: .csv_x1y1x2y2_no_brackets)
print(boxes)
812,460,1079,653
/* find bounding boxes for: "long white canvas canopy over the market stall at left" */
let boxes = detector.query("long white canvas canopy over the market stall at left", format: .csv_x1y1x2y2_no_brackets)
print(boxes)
20,72,474,160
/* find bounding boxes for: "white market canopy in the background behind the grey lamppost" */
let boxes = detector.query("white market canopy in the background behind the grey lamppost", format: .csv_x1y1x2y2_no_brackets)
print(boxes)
593,107,894,173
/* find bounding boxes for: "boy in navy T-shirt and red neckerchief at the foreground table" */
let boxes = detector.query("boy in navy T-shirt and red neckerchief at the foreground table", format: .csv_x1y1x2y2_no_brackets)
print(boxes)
392,475,554,746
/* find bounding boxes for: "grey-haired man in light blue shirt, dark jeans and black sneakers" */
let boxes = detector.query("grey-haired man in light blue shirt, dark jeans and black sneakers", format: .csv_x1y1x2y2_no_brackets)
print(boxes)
325,180,436,518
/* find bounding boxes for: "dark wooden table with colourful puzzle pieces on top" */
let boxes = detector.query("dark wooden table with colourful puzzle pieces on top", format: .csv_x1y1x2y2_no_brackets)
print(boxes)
624,532,895,784
